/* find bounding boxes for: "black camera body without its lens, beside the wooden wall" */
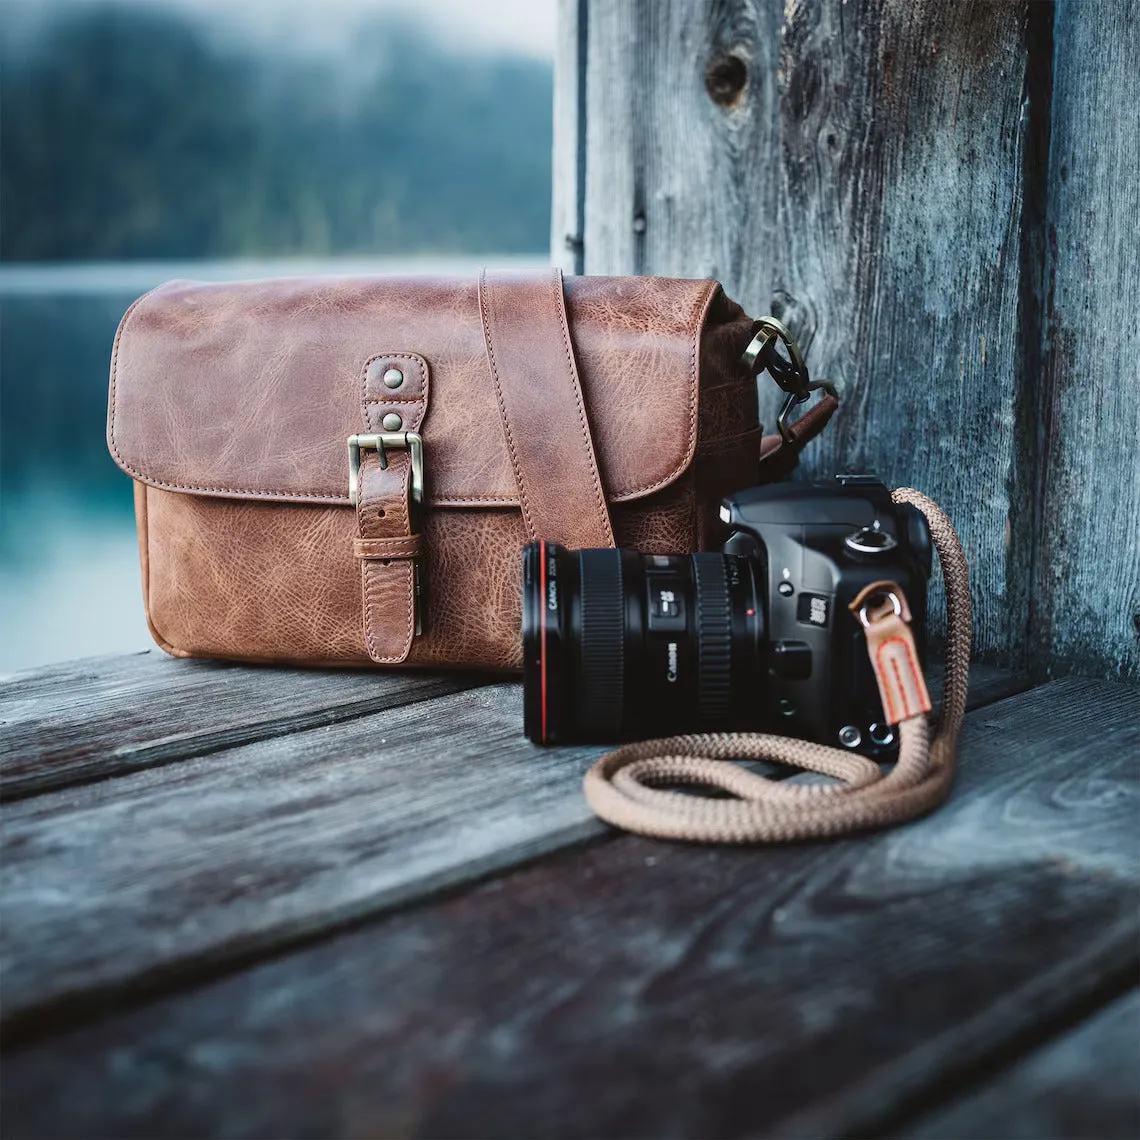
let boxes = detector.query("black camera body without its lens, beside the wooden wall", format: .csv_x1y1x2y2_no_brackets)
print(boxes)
720,475,933,755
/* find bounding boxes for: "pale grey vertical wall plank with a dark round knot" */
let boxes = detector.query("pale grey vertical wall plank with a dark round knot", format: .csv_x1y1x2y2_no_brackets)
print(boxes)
583,0,781,285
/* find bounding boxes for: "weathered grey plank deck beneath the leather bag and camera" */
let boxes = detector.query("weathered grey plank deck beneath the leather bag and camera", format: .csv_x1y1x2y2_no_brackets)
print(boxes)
0,652,1140,1138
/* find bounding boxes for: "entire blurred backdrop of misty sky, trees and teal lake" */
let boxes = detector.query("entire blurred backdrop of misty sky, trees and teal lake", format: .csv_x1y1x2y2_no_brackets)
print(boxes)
0,0,553,671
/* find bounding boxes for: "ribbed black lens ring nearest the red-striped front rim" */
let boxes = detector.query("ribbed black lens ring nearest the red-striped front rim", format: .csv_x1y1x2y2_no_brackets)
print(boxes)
578,551,626,738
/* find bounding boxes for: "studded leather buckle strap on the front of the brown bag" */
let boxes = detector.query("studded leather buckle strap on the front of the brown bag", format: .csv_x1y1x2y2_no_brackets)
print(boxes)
352,352,429,665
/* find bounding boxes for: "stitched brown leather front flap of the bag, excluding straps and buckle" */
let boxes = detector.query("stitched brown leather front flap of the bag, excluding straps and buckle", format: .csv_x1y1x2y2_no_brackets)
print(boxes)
107,277,716,506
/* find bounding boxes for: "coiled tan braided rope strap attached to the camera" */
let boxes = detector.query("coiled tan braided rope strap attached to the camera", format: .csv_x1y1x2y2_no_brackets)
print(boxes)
584,488,972,844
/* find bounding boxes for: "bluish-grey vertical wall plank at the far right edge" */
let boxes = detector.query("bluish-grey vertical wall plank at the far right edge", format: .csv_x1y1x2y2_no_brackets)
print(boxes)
1031,0,1140,677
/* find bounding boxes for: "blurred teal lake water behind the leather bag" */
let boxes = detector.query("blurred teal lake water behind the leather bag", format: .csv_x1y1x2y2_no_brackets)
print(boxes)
0,258,545,673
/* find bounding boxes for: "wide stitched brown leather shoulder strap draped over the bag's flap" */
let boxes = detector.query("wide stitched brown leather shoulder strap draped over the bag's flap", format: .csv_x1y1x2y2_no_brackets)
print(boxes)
479,269,614,549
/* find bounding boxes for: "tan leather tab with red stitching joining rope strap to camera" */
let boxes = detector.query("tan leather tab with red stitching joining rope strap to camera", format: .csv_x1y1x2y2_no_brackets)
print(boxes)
849,581,931,724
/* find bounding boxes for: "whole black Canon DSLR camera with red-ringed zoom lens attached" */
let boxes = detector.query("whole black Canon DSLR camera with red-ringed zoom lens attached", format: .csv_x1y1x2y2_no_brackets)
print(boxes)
522,475,931,756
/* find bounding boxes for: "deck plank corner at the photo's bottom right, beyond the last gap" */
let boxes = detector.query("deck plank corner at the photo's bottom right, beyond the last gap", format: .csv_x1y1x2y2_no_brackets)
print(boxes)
906,990,1140,1140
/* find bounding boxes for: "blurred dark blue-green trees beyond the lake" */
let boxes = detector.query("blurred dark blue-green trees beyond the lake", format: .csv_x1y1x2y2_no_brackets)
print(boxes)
0,5,552,261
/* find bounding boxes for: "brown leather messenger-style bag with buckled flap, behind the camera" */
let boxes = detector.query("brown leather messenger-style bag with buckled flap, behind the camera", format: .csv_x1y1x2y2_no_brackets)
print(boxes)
107,270,833,668
